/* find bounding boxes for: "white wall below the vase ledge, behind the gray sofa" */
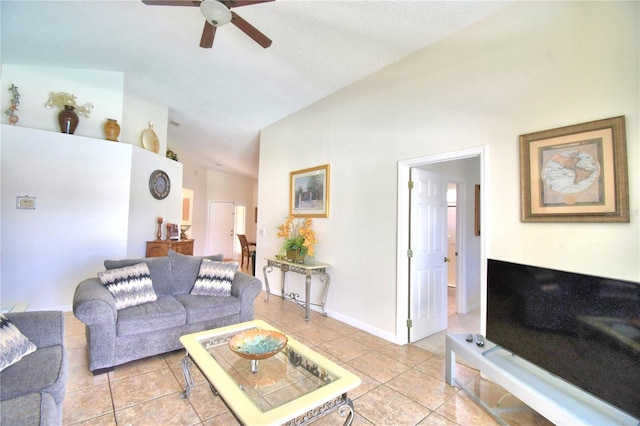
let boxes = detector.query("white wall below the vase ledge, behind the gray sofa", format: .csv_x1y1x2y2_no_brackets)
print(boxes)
0,125,182,310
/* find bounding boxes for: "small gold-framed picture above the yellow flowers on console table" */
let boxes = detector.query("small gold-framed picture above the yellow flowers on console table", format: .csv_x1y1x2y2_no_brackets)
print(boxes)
289,164,330,217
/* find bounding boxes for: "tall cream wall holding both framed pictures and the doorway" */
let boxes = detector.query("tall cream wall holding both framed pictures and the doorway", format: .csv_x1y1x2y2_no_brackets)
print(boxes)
257,2,640,341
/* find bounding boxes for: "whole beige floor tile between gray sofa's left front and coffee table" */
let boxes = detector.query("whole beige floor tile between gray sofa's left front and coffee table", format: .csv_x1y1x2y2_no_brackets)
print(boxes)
111,367,182,410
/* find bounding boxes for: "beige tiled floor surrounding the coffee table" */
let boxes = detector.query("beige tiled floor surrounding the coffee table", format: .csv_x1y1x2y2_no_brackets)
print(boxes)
63,288,546,426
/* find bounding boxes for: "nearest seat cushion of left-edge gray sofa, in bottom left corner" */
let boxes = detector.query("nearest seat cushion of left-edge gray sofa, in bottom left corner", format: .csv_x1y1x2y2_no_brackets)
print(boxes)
0,392,60,426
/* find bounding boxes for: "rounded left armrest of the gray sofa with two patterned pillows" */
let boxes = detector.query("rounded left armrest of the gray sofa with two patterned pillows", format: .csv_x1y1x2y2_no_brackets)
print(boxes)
73,278,118,325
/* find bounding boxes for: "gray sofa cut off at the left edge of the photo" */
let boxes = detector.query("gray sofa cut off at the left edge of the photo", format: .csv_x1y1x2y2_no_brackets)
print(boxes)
0,311,68,426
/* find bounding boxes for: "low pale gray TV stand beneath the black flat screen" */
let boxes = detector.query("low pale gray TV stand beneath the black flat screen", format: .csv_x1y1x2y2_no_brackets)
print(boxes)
445,334,640,426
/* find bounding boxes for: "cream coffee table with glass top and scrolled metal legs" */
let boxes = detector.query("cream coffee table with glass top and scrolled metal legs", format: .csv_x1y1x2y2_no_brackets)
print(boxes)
180,320,360,426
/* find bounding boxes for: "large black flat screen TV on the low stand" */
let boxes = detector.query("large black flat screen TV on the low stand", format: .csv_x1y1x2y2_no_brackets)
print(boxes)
486,259,640,419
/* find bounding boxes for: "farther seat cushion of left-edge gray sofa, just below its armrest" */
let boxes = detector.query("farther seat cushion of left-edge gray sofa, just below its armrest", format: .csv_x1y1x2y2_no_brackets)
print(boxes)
0,345,67,404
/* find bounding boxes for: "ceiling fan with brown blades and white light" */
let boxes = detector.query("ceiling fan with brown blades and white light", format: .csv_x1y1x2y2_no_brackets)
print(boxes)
142,0,275,49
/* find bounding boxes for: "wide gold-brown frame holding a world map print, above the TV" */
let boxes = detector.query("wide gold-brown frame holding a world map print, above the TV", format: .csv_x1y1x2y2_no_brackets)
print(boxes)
520,116,630,223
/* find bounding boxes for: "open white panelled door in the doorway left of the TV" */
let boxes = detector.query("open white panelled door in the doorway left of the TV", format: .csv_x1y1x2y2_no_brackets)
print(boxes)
409,168,447,342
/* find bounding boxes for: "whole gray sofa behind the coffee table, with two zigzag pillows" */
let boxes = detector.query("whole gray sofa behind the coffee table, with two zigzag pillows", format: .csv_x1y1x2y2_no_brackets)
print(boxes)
73,250,262,374
